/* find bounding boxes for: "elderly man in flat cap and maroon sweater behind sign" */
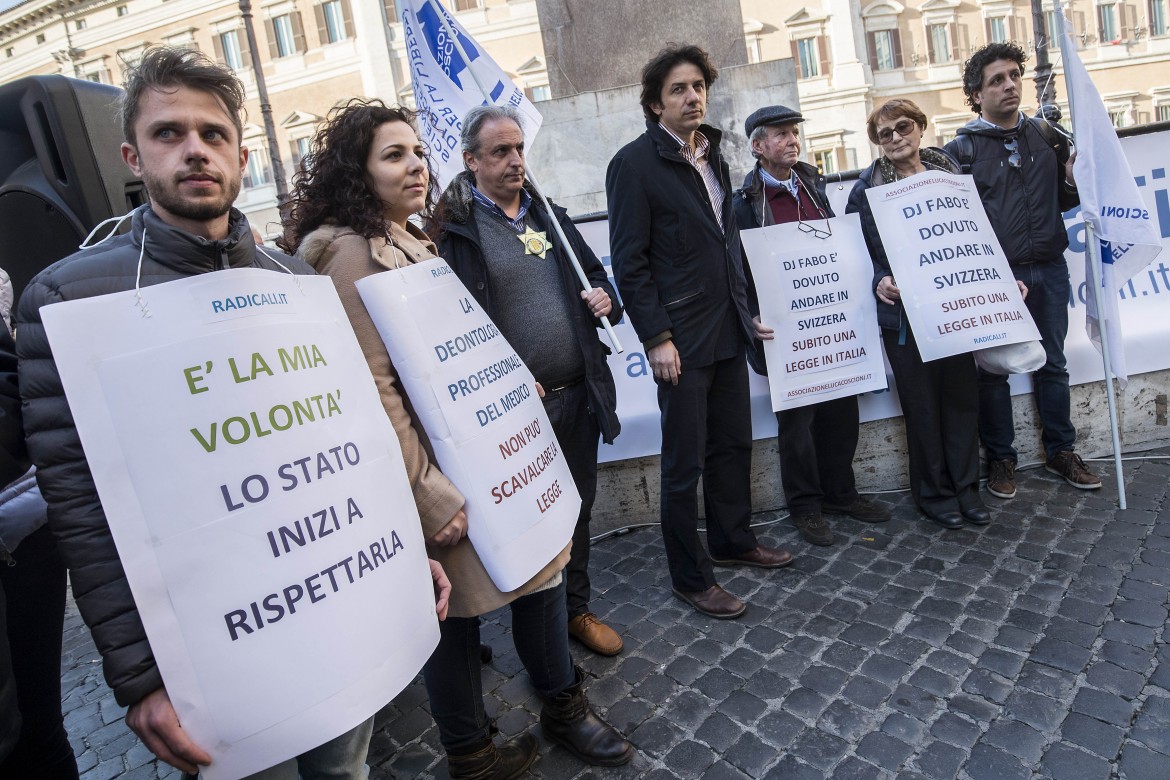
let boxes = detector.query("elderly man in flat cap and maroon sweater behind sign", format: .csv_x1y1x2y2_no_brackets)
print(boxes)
734,105,889,546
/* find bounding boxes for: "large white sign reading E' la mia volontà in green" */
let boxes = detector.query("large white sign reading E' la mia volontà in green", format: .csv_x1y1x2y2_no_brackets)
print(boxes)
41,269,439,780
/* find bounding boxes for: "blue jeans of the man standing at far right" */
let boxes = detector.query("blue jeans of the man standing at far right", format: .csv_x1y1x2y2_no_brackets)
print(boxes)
979,258,1076,461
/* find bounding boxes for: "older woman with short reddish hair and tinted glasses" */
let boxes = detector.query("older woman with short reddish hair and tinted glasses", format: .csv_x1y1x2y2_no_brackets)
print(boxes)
846,98,991,529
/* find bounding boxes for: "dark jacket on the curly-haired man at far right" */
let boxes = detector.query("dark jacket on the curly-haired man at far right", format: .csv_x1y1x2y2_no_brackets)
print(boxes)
945,117,1081,265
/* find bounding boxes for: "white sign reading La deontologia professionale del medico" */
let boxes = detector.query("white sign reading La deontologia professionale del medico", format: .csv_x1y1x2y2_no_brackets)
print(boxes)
357,258,581,593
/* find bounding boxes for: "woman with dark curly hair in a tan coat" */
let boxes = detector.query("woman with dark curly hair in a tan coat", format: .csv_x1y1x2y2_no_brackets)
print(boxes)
277,99,634,780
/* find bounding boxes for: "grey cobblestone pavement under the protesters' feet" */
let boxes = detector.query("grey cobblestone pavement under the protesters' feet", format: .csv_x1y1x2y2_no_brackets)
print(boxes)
63,450,1170,780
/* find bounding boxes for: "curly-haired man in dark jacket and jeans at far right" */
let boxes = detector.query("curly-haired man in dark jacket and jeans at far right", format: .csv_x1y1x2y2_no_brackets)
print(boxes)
947,43,1101,498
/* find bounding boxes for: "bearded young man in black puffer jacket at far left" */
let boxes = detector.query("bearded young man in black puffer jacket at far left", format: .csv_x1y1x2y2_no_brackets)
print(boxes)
18,48,449,780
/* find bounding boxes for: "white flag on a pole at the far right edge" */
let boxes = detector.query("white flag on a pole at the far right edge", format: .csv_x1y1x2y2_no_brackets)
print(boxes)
1058,9,1162,387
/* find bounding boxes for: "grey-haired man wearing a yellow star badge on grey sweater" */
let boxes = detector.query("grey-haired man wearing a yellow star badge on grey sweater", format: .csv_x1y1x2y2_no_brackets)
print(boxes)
433,105,622,655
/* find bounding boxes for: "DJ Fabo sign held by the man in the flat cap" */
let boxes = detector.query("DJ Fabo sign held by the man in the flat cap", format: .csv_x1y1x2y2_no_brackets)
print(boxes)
739,214,886,412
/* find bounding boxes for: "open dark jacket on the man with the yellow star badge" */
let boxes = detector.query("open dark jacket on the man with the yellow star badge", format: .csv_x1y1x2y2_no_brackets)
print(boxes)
431,172,621,444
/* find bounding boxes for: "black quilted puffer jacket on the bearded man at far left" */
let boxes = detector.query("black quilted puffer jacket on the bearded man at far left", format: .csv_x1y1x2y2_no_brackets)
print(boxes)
16,207,312,706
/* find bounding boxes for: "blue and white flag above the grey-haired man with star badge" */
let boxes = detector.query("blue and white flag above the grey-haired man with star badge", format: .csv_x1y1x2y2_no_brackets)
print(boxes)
398,0,542,187
